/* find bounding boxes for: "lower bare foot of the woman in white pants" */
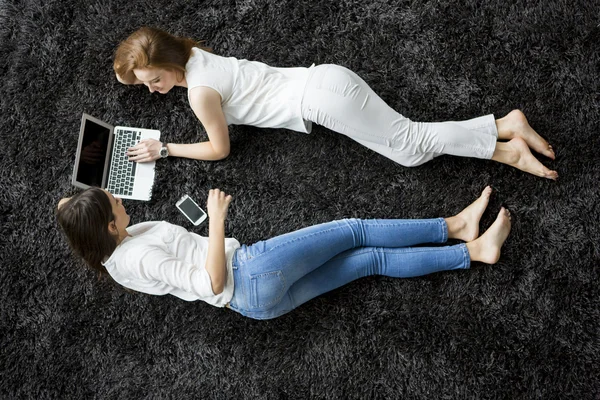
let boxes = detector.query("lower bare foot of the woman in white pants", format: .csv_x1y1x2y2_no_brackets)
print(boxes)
492,137,558,180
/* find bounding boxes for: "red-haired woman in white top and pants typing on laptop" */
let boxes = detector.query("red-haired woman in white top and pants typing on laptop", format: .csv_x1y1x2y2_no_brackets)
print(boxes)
114,27,558,179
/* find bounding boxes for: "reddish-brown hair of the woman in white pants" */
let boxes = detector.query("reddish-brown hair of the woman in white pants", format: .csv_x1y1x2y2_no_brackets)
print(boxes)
113,26,211,83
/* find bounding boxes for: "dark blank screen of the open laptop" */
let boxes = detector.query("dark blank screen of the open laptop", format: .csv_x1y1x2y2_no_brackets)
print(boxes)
76,119,110,187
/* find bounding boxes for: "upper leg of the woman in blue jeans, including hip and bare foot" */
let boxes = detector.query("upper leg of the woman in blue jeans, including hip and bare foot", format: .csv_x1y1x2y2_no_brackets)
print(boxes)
232,187,491,318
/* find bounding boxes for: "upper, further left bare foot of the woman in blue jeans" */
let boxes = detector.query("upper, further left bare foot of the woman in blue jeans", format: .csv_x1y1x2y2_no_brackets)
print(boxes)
446,186,492,242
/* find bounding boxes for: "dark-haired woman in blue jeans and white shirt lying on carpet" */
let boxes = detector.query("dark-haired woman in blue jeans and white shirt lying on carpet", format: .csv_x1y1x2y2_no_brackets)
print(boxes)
57,187,511,319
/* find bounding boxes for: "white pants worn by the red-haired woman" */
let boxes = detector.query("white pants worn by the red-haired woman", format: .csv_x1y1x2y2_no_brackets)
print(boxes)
302,64,498,167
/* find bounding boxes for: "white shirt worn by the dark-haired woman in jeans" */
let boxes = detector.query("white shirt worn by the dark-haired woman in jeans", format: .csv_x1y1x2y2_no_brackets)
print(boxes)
103,221,240,307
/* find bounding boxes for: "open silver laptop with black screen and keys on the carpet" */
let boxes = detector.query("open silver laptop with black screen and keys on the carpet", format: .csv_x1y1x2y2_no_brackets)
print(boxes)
71,113,160,201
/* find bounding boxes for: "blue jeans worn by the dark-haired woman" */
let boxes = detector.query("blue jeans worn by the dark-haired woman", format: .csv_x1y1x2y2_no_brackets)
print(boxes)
229,218,470,319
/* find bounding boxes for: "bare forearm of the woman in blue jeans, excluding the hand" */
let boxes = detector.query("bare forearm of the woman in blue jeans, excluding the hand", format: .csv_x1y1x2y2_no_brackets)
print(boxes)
205,218,227,294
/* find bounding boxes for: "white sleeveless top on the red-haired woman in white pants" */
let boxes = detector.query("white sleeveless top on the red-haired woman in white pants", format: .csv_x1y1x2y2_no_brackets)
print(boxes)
185,47,312,133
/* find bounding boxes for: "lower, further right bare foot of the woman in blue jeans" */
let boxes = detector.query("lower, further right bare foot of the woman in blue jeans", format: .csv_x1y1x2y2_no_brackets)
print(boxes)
467,207,511,264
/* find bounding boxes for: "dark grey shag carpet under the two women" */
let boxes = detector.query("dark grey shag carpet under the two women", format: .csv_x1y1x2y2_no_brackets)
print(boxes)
0,0,600,399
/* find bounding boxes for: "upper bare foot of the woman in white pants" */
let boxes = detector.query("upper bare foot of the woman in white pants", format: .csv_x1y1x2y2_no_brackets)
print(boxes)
496,110,556,160
